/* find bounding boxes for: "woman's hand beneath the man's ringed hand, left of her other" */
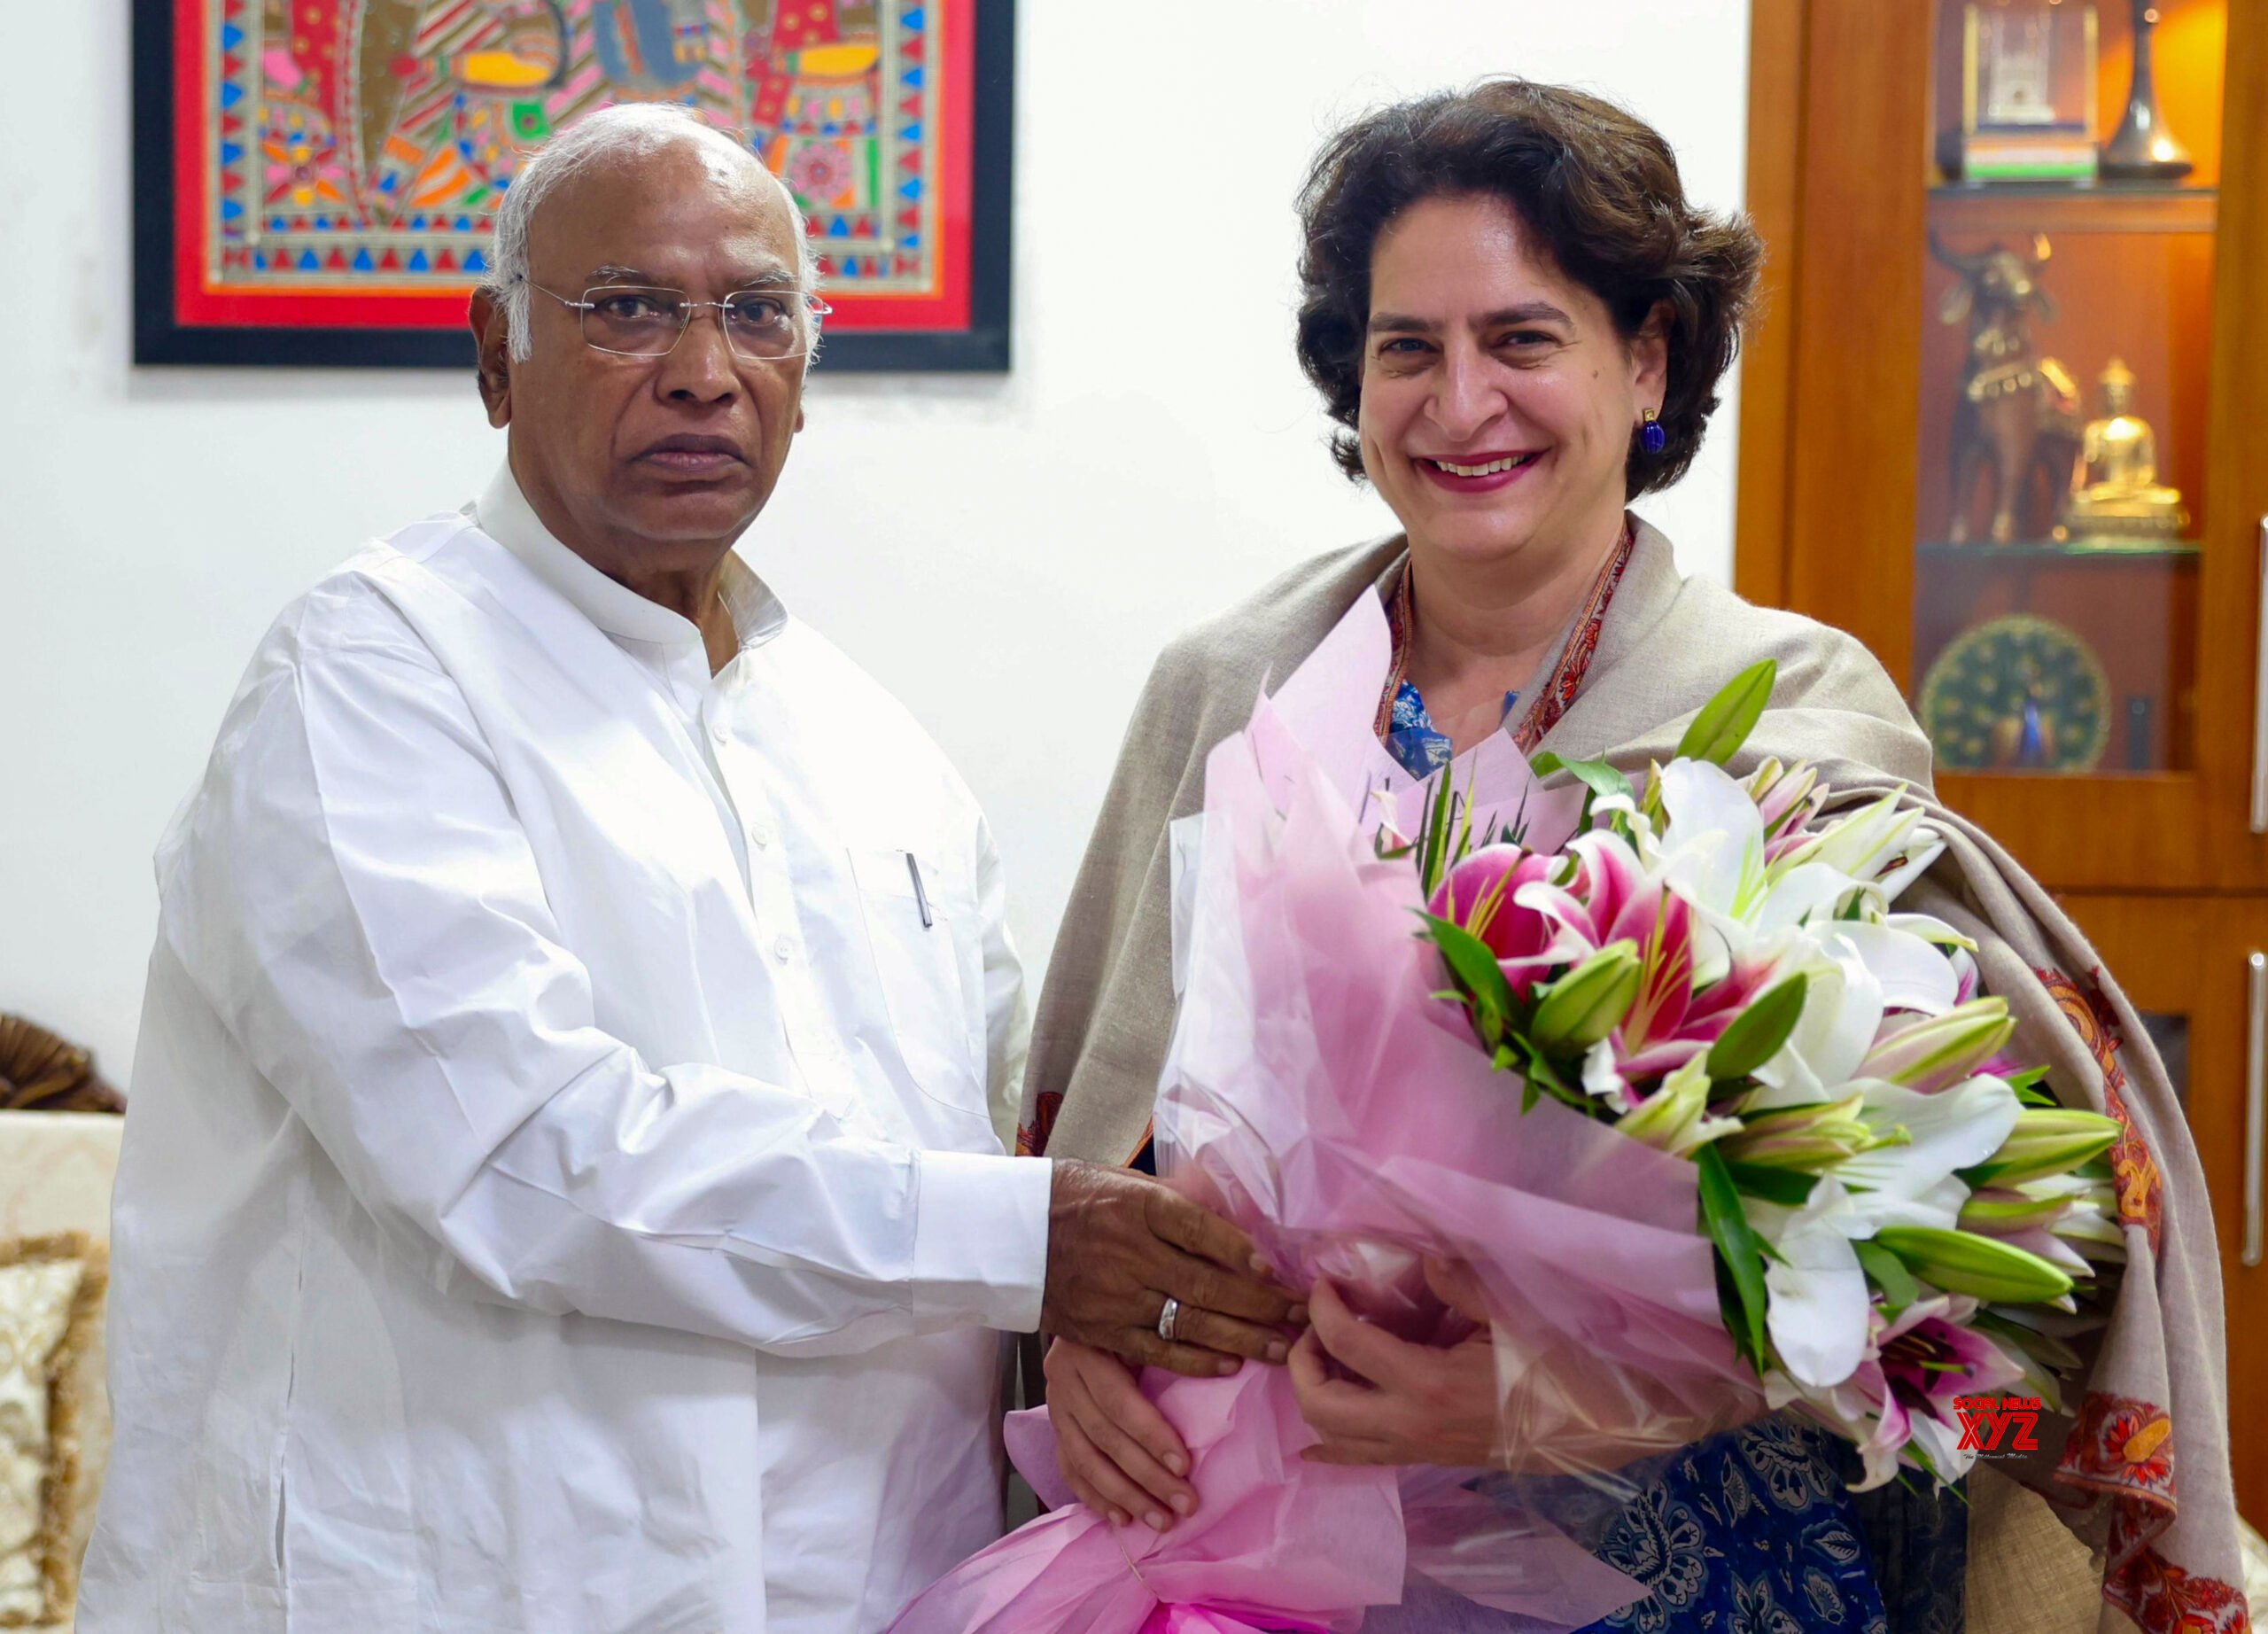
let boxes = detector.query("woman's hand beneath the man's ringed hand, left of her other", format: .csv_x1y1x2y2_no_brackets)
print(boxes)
1045,1339,1198,1532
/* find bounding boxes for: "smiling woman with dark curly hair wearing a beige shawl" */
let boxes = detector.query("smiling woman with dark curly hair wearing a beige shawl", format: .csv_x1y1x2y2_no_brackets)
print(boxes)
1002,66,2241,1634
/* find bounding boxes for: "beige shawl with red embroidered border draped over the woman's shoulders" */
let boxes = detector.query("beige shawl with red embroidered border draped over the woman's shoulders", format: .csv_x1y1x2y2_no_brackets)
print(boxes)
1018,522,2245,1634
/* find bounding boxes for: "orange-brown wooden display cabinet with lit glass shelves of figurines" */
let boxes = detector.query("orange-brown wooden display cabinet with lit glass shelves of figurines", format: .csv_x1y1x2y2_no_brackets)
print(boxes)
1737,0,2268,1521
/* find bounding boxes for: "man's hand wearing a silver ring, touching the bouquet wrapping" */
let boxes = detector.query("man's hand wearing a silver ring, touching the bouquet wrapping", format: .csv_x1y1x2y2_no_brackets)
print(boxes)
1038,1160,1307,1378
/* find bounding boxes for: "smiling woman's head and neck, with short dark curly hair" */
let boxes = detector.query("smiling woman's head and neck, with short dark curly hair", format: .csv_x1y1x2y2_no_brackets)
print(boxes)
1297,80,1762,765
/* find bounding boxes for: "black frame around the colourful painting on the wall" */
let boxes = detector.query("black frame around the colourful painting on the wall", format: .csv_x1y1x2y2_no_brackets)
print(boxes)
131,0,1016,375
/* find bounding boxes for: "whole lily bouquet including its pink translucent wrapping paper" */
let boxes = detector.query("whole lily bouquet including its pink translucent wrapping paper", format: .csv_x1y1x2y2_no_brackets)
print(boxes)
894,597,2116,1634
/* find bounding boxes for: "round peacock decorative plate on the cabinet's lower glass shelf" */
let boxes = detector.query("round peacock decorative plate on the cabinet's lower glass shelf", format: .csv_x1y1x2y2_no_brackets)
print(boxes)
1921,613,2111,772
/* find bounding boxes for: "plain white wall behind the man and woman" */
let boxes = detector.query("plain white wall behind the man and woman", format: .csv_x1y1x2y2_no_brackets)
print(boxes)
0,0,1749,1083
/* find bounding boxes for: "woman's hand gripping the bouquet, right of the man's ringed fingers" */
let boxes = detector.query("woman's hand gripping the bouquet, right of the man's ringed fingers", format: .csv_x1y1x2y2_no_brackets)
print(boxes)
1291,1259,1502,1468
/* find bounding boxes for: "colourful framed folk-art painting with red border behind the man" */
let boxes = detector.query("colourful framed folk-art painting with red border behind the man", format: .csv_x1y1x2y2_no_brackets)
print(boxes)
134,0,1014,370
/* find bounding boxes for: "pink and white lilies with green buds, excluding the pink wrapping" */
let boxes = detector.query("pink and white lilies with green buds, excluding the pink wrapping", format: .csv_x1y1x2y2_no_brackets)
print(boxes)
1415,663,2123,1487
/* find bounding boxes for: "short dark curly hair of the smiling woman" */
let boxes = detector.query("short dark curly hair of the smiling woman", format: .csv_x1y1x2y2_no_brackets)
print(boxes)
1300,77,1765,497
